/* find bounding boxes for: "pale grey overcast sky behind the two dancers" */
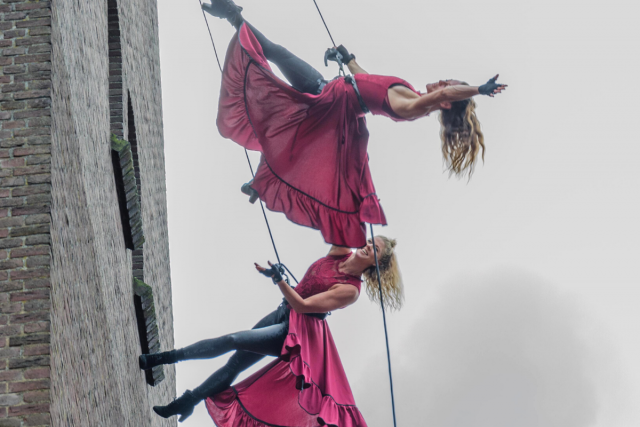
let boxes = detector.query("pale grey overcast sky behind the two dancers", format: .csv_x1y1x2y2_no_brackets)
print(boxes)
159,0,640,427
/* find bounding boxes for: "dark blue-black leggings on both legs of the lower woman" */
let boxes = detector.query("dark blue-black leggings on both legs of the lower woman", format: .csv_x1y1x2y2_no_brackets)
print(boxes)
178,304,289,400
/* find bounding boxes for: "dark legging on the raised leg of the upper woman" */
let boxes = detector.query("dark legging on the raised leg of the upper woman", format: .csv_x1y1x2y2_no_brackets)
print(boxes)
245,21,327,95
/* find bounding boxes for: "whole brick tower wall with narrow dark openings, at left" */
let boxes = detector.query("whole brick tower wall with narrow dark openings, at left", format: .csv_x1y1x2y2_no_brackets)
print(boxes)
0,0,176,427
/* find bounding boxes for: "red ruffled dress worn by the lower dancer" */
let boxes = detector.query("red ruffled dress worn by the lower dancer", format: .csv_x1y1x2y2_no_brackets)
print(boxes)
206,255,367,427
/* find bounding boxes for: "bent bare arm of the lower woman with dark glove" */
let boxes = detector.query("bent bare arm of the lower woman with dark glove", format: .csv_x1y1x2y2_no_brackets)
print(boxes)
255,263,360,313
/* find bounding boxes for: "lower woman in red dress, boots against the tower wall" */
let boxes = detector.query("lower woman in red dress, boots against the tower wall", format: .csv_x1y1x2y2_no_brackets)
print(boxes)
140,236,403,427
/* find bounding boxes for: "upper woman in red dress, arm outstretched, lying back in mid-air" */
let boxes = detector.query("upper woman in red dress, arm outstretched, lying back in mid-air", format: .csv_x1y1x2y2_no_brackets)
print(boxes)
203,0,505,248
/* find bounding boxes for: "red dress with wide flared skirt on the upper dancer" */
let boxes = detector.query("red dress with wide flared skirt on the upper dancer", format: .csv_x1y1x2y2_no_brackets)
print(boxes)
217,25,419,248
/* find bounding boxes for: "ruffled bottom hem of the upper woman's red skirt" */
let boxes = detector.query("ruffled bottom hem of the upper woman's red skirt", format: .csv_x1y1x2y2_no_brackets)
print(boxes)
251,164,387,248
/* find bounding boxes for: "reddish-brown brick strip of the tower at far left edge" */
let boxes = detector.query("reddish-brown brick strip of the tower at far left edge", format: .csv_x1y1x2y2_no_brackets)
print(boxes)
0,0,51,427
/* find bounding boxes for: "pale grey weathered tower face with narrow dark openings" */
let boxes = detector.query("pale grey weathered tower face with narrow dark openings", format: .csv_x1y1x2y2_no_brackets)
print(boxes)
47,0,177,427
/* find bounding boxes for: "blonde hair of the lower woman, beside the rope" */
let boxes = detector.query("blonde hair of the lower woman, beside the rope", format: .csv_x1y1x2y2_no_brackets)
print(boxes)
362,236,404,311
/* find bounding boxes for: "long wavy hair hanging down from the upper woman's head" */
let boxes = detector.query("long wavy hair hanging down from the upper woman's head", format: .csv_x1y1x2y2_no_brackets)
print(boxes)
440,97,485,178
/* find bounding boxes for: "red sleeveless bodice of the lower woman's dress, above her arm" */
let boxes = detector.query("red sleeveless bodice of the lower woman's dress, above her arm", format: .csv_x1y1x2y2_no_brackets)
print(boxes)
295,254,362,299
